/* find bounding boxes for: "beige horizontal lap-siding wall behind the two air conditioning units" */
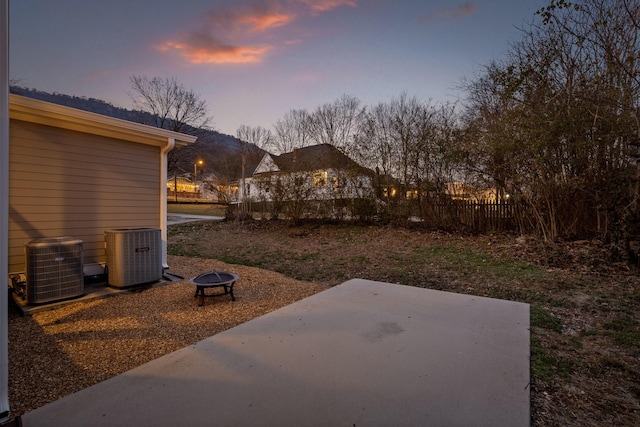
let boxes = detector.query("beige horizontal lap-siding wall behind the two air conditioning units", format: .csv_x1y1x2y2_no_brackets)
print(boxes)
9,119,161,273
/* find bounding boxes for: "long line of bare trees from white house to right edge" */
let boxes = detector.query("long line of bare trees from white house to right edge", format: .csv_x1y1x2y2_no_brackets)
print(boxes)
130,0,640,252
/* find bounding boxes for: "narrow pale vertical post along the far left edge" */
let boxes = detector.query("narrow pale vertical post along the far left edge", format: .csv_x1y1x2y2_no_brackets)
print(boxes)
0,0,10,422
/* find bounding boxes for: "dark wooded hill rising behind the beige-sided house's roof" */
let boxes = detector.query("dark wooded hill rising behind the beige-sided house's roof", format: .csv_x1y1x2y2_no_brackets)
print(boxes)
10,86,266,180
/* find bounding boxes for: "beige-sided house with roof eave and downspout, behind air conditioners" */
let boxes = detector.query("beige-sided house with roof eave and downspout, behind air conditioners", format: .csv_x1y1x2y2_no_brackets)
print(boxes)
8,95,196,273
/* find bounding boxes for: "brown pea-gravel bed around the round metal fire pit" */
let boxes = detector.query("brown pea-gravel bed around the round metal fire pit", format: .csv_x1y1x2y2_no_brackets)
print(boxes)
9,256,328,416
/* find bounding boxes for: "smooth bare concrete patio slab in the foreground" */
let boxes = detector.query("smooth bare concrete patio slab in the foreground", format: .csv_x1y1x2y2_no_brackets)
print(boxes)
22,279,530,427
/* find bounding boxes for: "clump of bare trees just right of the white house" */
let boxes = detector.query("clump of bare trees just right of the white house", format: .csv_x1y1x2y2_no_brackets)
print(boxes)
355,92,460,221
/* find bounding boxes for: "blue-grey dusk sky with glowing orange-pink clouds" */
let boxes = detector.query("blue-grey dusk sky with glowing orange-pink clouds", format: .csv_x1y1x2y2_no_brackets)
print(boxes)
10,0,547,135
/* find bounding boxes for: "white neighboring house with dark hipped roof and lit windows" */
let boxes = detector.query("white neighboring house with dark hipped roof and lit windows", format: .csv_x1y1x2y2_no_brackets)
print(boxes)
237,144,375,208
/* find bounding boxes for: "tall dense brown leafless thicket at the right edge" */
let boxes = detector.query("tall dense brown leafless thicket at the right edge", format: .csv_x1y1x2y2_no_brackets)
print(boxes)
466,0,640,240
